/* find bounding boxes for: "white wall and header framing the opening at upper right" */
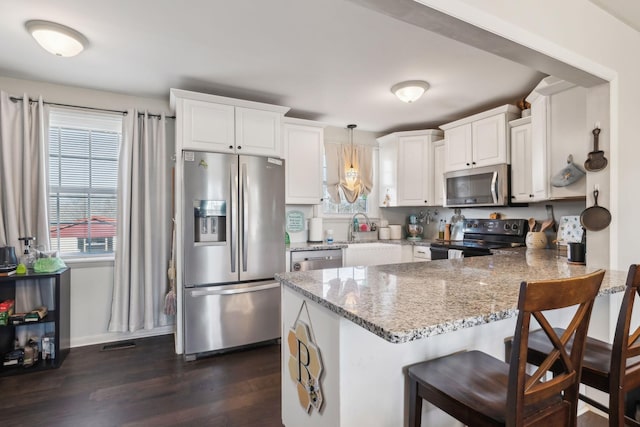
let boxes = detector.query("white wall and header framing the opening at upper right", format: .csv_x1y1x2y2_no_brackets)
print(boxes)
417,0,640,270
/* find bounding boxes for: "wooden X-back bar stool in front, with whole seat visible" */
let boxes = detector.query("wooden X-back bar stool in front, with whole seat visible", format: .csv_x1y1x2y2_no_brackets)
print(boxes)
408,270,604,427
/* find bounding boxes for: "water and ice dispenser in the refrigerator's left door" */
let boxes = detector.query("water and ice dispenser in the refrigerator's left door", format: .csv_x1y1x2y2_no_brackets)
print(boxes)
193,200,227,243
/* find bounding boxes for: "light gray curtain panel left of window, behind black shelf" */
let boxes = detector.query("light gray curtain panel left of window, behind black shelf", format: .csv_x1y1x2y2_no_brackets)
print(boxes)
0,91,49,312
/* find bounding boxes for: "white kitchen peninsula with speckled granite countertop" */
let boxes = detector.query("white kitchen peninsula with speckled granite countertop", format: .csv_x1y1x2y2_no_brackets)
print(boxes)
277,249,626,427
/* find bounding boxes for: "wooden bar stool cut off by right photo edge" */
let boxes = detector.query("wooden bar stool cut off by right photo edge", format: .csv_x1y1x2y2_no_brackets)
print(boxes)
505,264,640,427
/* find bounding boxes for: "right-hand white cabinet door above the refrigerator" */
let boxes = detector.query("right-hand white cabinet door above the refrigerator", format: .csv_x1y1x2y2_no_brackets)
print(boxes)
236,107,282,157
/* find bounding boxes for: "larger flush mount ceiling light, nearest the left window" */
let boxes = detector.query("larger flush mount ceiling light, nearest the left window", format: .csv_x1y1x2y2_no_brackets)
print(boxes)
24,20,89,57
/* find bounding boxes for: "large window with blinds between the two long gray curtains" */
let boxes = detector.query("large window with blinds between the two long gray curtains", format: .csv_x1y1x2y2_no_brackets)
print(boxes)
49,108,122,256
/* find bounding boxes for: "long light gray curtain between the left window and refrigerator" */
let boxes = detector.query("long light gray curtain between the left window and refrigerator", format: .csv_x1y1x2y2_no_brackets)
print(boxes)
109,110,173,332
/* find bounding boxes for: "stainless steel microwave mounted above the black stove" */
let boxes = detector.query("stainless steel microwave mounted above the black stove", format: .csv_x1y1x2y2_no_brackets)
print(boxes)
444,164,510,207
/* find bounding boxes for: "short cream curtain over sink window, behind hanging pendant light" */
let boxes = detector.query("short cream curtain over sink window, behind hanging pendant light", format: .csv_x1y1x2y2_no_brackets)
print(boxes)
324,142,373,203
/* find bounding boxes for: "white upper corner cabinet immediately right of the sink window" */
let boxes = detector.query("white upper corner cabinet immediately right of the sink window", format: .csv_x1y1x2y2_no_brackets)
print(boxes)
378,129,443,207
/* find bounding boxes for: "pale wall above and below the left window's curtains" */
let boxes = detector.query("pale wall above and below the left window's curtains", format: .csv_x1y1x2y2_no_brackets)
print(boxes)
0,76,173,347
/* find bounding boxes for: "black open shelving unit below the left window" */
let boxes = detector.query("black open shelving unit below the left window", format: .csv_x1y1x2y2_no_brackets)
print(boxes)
0,267,71,377
